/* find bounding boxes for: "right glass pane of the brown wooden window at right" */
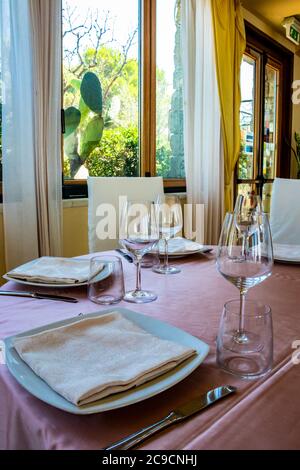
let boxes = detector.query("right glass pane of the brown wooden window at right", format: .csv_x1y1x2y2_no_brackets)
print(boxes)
263,65,279,179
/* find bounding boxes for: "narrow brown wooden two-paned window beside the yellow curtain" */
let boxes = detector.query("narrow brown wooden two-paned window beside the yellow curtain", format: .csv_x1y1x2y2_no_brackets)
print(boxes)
235,23,293,212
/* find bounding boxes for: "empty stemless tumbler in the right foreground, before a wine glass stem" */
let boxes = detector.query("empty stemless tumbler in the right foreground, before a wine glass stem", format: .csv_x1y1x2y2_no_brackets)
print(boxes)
217,300,273,378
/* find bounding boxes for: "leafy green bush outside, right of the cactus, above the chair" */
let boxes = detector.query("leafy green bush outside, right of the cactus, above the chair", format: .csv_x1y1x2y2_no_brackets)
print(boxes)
86,126,139,176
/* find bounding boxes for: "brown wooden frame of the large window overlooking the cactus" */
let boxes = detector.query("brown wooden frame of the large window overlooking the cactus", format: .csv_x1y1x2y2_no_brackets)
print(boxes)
61,0,186,199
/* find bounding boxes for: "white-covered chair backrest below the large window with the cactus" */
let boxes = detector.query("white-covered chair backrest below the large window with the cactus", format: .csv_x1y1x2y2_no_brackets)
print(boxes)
88,177,164,253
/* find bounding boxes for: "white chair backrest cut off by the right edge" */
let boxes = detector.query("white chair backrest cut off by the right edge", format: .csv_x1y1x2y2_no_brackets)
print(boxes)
270,178,300,245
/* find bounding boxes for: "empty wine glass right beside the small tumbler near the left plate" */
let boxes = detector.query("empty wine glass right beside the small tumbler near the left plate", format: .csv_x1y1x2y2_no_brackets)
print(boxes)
120,201,159,303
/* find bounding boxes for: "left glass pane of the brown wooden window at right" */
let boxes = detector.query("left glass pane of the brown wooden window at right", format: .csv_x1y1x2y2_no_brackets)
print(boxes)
238,54,256,179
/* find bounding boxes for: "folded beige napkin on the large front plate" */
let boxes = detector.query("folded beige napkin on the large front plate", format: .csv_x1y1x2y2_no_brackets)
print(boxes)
14,312,195,405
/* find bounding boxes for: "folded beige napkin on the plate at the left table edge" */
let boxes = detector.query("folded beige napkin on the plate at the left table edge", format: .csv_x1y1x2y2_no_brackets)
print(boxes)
7,256,90,284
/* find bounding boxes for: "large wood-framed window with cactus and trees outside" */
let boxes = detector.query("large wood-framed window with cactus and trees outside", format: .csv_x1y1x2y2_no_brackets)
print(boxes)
62,0,185,197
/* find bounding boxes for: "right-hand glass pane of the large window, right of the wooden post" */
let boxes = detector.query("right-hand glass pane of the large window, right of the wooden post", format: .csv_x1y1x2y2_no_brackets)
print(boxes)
156,0,185,178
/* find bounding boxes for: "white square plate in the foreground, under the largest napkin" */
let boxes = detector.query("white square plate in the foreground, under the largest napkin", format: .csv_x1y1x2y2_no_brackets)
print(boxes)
4,307,209,415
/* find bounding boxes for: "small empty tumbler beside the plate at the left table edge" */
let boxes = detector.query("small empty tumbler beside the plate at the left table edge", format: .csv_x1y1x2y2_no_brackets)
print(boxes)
88,255,125,305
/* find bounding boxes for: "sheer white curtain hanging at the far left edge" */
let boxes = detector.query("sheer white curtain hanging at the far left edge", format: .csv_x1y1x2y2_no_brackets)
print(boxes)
1,0,62,269
